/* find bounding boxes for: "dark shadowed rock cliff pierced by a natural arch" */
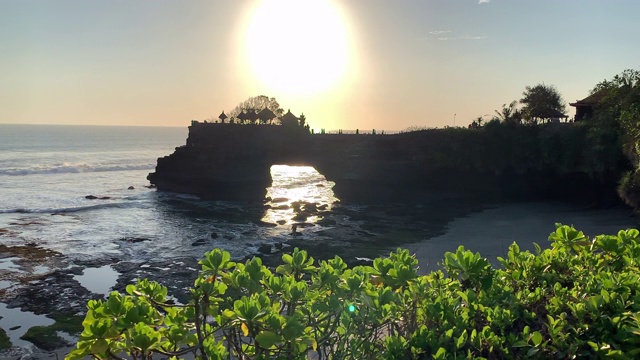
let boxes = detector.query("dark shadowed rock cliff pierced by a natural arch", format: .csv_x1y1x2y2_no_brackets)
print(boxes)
148,123,623,201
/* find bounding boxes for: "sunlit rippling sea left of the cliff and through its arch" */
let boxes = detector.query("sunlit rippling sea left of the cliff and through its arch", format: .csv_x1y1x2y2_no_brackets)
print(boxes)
0,125,344,261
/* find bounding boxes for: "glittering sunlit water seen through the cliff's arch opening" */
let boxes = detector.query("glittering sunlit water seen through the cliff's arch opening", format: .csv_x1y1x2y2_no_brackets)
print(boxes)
262,165,338,225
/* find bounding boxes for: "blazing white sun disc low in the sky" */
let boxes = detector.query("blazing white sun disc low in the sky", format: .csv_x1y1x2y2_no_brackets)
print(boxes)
244,0,351,96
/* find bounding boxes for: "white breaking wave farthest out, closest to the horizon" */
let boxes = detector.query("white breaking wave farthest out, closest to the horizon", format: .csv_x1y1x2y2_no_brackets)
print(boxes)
0,163,155,176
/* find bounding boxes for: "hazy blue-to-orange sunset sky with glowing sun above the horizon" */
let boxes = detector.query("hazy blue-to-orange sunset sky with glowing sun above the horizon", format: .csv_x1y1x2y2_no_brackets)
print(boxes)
0,0,640,131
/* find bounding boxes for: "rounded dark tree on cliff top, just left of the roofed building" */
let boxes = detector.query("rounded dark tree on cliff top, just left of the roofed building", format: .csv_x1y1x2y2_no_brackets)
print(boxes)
520,84,567,124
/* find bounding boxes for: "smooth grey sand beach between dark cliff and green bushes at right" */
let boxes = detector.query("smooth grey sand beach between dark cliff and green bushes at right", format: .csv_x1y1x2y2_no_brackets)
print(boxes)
405,203,640,274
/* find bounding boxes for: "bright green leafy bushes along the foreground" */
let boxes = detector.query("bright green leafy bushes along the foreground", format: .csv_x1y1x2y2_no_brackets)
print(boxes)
67,224,640,359
